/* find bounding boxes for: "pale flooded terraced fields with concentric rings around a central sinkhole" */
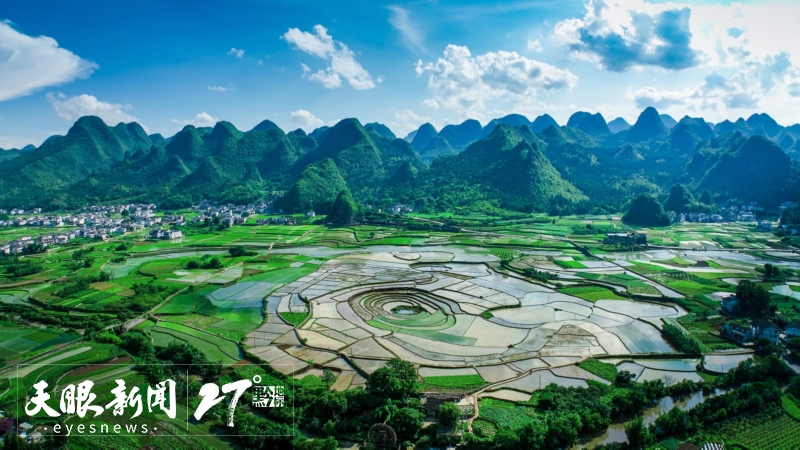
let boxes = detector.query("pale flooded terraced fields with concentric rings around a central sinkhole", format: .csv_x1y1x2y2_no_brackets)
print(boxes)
245,251,685,381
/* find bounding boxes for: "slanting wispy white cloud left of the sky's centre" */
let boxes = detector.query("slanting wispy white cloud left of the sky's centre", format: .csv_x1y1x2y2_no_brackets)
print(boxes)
281,25,375,90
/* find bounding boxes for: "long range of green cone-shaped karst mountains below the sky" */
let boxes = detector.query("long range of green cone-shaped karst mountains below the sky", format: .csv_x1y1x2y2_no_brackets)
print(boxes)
0,108,800,213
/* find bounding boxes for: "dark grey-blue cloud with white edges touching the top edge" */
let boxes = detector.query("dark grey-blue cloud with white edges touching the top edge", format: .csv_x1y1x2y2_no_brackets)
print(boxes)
555,0,702,72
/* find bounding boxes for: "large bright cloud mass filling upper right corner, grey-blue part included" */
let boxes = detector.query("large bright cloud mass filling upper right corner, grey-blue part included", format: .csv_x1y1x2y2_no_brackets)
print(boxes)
554,0,800,123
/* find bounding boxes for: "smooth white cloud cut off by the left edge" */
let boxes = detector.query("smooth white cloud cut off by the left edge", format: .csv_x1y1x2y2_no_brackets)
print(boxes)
0,20,98,101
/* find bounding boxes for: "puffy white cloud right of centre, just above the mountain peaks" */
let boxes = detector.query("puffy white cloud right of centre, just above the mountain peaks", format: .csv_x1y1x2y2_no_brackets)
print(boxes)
416,45,578,117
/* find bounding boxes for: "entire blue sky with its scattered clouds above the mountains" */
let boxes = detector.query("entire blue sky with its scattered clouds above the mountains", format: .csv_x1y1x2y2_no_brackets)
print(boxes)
0,0,800,148
